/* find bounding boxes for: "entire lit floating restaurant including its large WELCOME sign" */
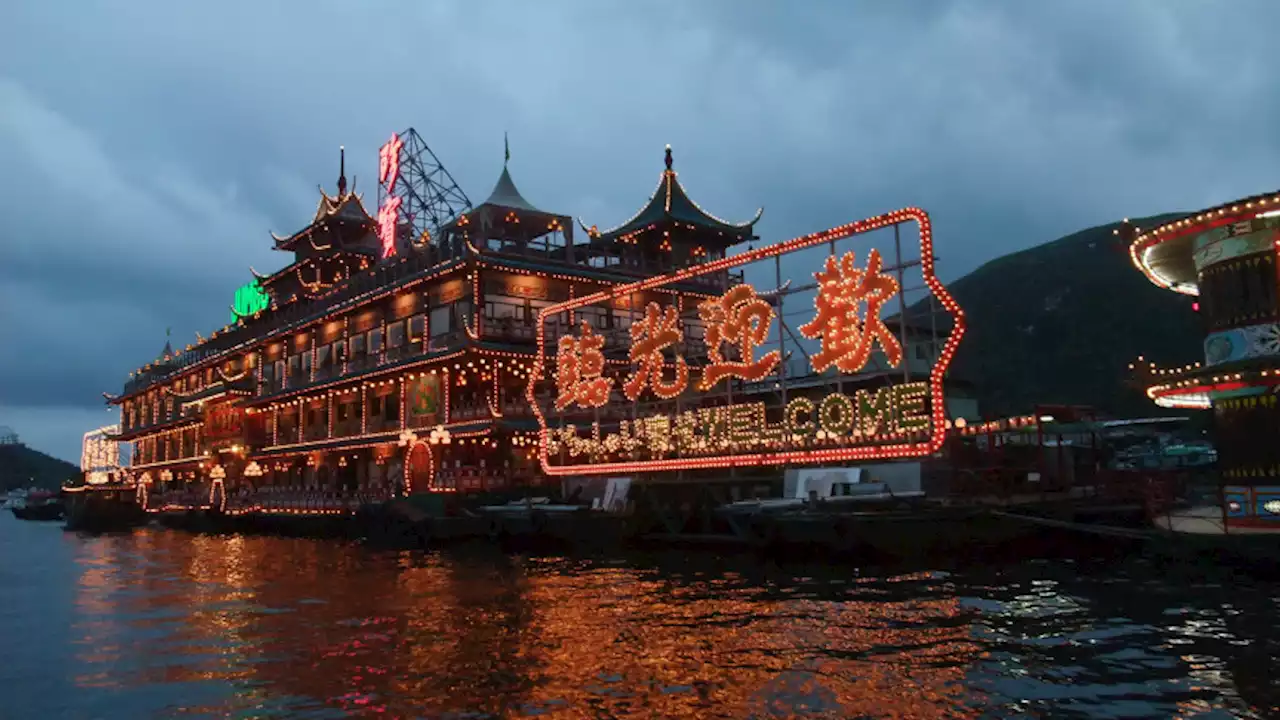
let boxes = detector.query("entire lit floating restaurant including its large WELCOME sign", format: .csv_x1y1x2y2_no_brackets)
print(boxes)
94,129,975,535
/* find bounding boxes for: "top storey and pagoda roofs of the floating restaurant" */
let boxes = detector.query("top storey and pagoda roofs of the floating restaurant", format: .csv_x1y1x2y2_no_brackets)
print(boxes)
108,140,759,437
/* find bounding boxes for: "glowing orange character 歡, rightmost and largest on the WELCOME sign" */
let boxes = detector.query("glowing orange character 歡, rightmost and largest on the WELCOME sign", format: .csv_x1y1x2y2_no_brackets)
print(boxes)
800,249,902,373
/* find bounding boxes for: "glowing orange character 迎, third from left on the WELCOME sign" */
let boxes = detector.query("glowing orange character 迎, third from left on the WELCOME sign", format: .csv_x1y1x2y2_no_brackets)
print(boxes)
698,284,782,391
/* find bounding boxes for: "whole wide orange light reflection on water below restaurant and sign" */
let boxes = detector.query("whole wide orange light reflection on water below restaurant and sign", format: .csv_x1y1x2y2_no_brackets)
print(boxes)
70,530,979,717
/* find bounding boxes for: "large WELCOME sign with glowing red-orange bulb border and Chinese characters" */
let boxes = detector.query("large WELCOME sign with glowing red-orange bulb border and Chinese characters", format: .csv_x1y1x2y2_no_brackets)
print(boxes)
527,208,964,475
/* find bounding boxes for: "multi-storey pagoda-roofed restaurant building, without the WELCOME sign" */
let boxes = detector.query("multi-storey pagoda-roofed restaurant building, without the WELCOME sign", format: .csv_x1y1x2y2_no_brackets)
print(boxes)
108,142,760,512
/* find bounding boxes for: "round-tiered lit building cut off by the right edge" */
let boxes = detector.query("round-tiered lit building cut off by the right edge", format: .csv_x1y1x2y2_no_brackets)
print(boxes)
1117,193,1280,534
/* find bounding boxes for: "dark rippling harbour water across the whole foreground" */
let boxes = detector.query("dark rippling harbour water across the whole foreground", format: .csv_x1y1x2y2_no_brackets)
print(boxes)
0,516,1280,719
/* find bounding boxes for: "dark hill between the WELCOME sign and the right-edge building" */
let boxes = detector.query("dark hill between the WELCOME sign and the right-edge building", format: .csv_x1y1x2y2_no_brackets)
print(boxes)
921,215,1203,416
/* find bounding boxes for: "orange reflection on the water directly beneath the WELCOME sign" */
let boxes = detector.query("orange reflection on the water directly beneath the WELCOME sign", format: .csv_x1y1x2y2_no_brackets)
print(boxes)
512,569,978,717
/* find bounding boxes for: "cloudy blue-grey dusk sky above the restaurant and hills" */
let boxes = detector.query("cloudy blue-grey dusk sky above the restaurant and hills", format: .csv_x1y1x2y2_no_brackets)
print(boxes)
0,0,1280,460
